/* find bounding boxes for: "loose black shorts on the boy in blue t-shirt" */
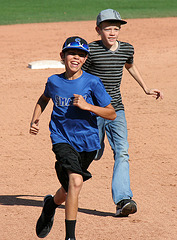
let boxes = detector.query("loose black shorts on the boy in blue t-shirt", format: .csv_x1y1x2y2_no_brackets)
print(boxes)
52,143,97,192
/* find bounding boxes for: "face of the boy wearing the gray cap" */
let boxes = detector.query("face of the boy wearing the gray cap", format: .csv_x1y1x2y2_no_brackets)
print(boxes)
96,21,121,49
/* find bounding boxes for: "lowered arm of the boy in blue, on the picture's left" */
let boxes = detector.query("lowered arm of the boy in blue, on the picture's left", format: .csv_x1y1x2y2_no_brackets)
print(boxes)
29,94,50,135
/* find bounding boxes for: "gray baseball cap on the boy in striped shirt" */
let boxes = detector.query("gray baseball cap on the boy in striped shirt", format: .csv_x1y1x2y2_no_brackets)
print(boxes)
96,9,127,26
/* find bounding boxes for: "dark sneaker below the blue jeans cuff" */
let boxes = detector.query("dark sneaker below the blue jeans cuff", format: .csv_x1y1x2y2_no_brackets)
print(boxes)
115,199,137,217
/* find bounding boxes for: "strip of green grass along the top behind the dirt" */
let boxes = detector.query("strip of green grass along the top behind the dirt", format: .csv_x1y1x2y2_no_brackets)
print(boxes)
0,0,177,25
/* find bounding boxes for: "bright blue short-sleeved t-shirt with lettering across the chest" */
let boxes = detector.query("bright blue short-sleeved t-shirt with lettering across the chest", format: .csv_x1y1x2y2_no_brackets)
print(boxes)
44,71,111,152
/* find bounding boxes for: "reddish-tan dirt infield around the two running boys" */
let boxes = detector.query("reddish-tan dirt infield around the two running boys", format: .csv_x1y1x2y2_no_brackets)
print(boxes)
0,18,177,240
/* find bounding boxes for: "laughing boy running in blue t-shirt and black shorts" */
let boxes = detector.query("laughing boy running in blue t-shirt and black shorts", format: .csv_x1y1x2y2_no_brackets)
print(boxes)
30,36,116,240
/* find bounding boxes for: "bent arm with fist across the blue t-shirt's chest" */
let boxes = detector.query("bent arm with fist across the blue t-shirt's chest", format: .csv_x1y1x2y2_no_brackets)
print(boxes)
73,94,117,120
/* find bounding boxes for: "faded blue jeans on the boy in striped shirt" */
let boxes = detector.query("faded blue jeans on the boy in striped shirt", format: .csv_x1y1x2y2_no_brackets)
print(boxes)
95,110,133,204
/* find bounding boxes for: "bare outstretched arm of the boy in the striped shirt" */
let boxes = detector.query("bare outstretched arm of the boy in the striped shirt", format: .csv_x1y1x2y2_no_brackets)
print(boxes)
125,63,163,99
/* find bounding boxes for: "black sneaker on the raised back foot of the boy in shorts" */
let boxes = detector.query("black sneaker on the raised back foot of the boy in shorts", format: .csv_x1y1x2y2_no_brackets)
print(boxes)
36,195,55,238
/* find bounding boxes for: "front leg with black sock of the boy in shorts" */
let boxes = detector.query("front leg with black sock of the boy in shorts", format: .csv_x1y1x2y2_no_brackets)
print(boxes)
65,171,83,240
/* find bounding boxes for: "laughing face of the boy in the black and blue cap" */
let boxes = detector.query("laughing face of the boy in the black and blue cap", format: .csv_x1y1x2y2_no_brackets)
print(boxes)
60,49,87,72
